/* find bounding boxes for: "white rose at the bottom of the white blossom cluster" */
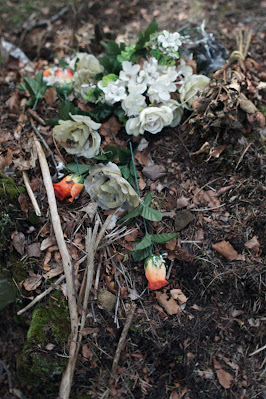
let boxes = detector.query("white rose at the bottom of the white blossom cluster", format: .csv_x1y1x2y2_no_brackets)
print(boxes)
126,105,173,136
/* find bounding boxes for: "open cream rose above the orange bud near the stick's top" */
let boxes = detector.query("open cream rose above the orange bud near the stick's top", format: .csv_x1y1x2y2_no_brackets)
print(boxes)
53,114,101,158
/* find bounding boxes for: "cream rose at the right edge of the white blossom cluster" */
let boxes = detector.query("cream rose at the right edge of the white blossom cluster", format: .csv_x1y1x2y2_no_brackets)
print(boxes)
179,75,210,110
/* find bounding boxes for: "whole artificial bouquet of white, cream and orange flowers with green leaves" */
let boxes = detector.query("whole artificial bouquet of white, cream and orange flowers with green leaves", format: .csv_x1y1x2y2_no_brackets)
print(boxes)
19,21,210,290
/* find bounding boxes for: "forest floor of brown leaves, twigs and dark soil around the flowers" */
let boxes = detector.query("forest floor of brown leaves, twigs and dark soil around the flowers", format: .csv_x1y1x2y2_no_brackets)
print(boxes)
0,0,266,399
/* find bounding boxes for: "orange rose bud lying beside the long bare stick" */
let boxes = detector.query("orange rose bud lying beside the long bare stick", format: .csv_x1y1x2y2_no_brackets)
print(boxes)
53,175,84,202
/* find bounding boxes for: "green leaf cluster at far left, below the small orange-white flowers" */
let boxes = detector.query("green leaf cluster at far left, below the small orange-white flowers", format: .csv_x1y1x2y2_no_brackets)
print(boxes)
17,71,48,107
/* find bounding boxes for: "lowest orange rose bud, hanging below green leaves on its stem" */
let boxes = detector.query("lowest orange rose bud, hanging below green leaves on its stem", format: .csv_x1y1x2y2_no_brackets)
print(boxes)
144,255,169,290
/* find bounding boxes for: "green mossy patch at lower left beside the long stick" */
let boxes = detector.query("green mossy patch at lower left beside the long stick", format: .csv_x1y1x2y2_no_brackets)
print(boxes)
18,291,70,397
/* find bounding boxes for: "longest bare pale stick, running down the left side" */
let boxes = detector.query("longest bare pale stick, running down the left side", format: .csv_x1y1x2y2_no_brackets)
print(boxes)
33,135,78,399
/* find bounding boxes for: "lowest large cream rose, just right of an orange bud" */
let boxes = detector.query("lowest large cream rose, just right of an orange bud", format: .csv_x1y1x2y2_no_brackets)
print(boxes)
84,162,139,209
